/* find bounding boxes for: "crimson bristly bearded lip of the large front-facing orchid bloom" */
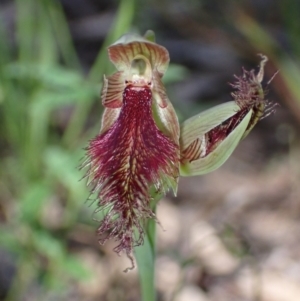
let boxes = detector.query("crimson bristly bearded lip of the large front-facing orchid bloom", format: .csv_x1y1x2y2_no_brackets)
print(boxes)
87,86,179,268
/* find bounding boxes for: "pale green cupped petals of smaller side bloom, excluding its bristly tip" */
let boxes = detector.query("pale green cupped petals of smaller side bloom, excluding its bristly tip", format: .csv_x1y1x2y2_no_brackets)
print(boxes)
180,102,253,176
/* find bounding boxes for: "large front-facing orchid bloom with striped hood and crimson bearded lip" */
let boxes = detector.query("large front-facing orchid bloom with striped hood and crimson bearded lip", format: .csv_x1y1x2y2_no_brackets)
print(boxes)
86,31,179,268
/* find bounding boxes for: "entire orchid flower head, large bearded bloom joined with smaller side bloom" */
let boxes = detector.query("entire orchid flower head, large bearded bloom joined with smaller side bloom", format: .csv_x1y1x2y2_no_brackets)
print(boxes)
84,32,272,268
